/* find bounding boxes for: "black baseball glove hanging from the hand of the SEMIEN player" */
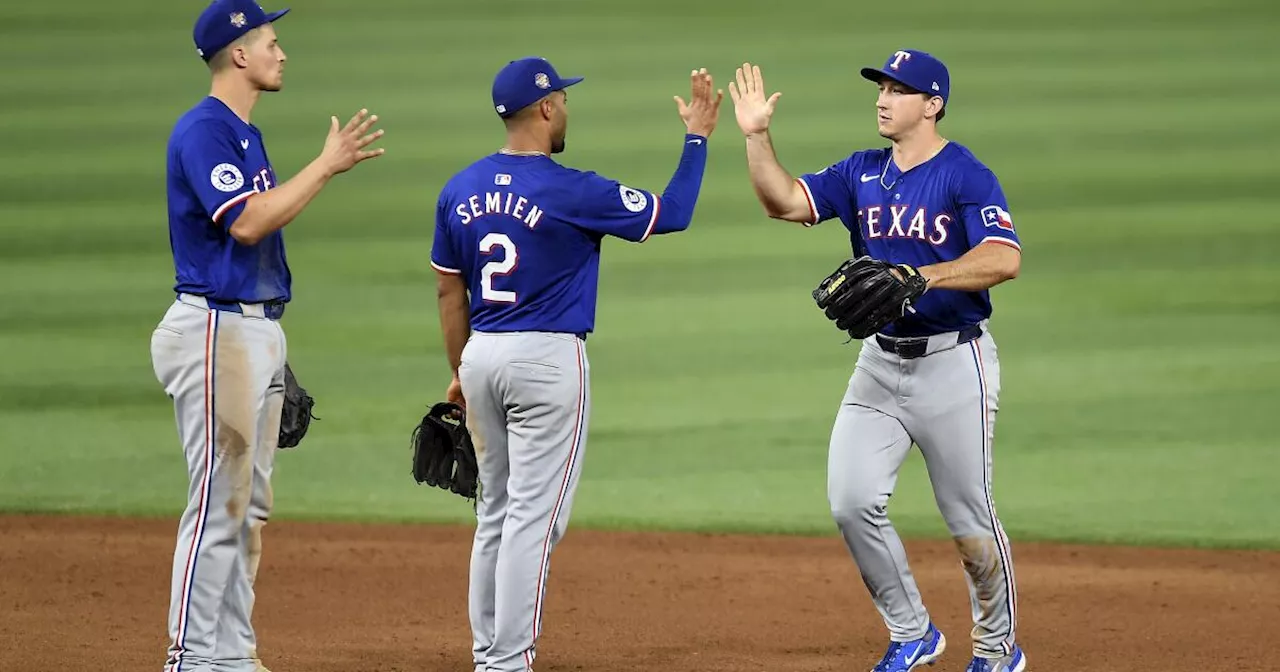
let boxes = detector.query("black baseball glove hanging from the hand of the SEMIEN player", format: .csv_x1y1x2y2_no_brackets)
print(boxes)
410,402,479,499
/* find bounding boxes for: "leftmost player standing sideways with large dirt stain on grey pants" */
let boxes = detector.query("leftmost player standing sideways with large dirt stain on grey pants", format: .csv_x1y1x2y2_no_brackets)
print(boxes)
151,0,383,672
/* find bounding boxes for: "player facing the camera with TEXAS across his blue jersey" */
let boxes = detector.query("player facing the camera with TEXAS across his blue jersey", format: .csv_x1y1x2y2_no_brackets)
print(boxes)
730,50,1027,672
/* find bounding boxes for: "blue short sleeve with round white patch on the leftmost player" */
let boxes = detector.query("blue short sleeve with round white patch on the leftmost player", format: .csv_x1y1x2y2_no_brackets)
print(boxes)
178,120,256,228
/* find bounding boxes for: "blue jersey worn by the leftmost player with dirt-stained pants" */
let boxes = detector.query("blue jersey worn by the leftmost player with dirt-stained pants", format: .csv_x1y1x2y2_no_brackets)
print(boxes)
165,96,291,303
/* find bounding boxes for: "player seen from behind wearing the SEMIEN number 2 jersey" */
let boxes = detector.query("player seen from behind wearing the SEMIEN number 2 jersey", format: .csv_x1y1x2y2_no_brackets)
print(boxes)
431,58,723,672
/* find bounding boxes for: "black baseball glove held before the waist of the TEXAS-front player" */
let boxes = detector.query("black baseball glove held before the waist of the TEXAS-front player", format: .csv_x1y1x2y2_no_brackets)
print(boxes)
813,256,925,338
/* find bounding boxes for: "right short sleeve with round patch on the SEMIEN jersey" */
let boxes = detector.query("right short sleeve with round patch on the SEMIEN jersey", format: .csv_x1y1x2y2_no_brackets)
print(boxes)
566,173,662,243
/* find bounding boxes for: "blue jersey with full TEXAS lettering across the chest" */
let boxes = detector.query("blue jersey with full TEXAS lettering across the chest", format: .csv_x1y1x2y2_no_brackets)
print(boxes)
797,142,1021,337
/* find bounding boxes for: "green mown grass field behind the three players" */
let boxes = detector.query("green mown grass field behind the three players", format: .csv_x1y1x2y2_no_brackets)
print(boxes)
0,0,1280,548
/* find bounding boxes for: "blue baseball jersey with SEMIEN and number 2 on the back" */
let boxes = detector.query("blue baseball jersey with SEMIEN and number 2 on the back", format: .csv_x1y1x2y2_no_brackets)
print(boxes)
431,154,662,335
